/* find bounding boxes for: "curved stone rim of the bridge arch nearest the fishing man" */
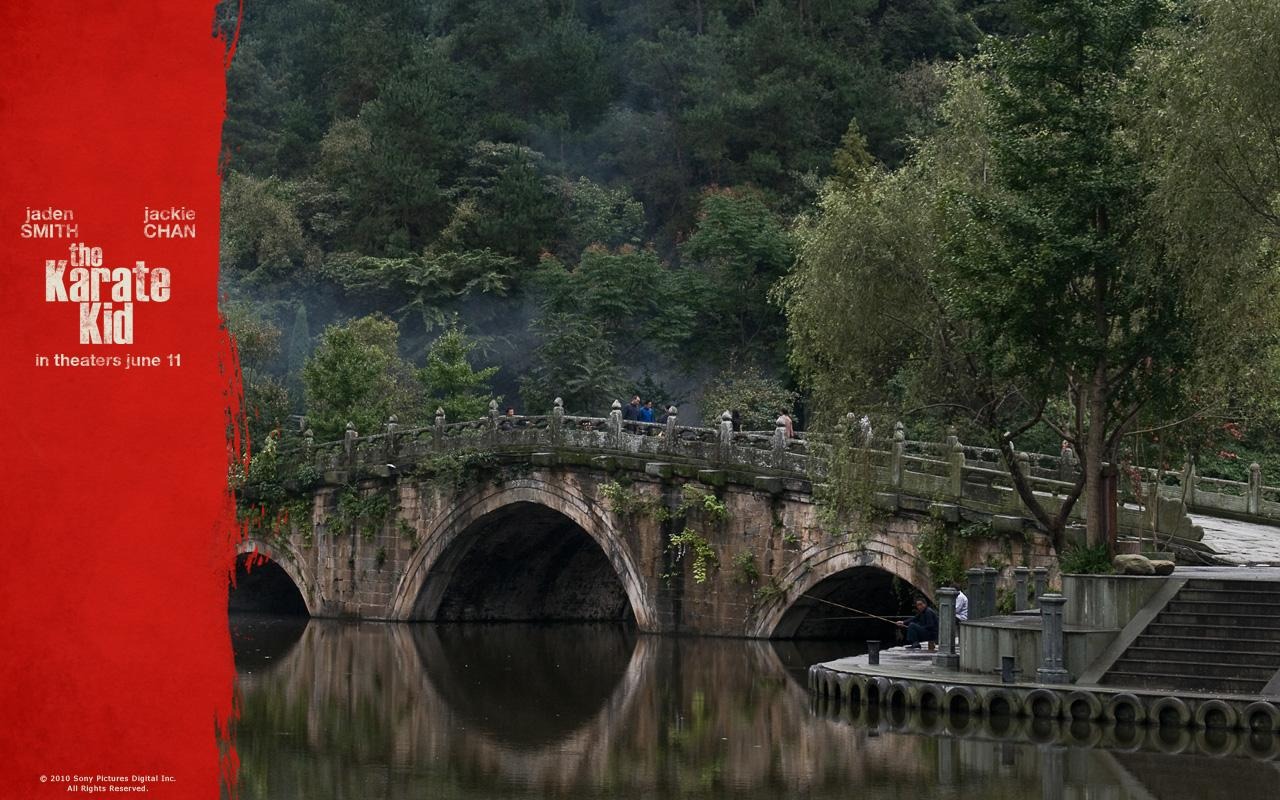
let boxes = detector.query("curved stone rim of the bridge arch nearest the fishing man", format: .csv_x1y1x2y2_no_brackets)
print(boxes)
750,535,933,639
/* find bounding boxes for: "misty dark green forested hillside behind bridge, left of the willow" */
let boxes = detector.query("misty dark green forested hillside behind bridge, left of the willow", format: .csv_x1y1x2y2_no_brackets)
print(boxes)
221,0,1006,430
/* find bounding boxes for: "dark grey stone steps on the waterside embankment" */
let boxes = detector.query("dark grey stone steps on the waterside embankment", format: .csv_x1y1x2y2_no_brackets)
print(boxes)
1102,579,1280,695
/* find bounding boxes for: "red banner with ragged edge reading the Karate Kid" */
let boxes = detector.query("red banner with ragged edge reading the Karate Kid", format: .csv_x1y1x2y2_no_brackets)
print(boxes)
0,0,234,797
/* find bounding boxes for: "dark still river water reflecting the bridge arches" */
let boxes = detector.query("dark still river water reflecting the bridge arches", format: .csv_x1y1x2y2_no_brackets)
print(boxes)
232,614,1280,800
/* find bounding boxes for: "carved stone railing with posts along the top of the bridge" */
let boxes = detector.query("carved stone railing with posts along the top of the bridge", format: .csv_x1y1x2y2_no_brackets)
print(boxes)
262,398,1280,522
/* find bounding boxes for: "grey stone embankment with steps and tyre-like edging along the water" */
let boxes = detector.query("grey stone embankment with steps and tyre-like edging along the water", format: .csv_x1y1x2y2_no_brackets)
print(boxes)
809,568,1280,735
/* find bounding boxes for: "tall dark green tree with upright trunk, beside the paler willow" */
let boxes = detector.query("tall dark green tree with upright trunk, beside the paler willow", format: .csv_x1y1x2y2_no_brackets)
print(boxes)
943,0,1172,544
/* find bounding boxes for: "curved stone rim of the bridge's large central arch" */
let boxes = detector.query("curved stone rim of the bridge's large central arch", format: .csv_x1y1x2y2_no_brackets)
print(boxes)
389,477,658,631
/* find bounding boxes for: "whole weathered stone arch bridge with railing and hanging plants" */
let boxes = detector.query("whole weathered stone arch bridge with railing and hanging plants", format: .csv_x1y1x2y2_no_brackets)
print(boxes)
232,402,1259,637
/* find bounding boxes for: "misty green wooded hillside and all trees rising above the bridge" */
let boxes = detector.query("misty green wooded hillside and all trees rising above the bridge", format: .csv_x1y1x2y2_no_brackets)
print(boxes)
221,0,1280,540
